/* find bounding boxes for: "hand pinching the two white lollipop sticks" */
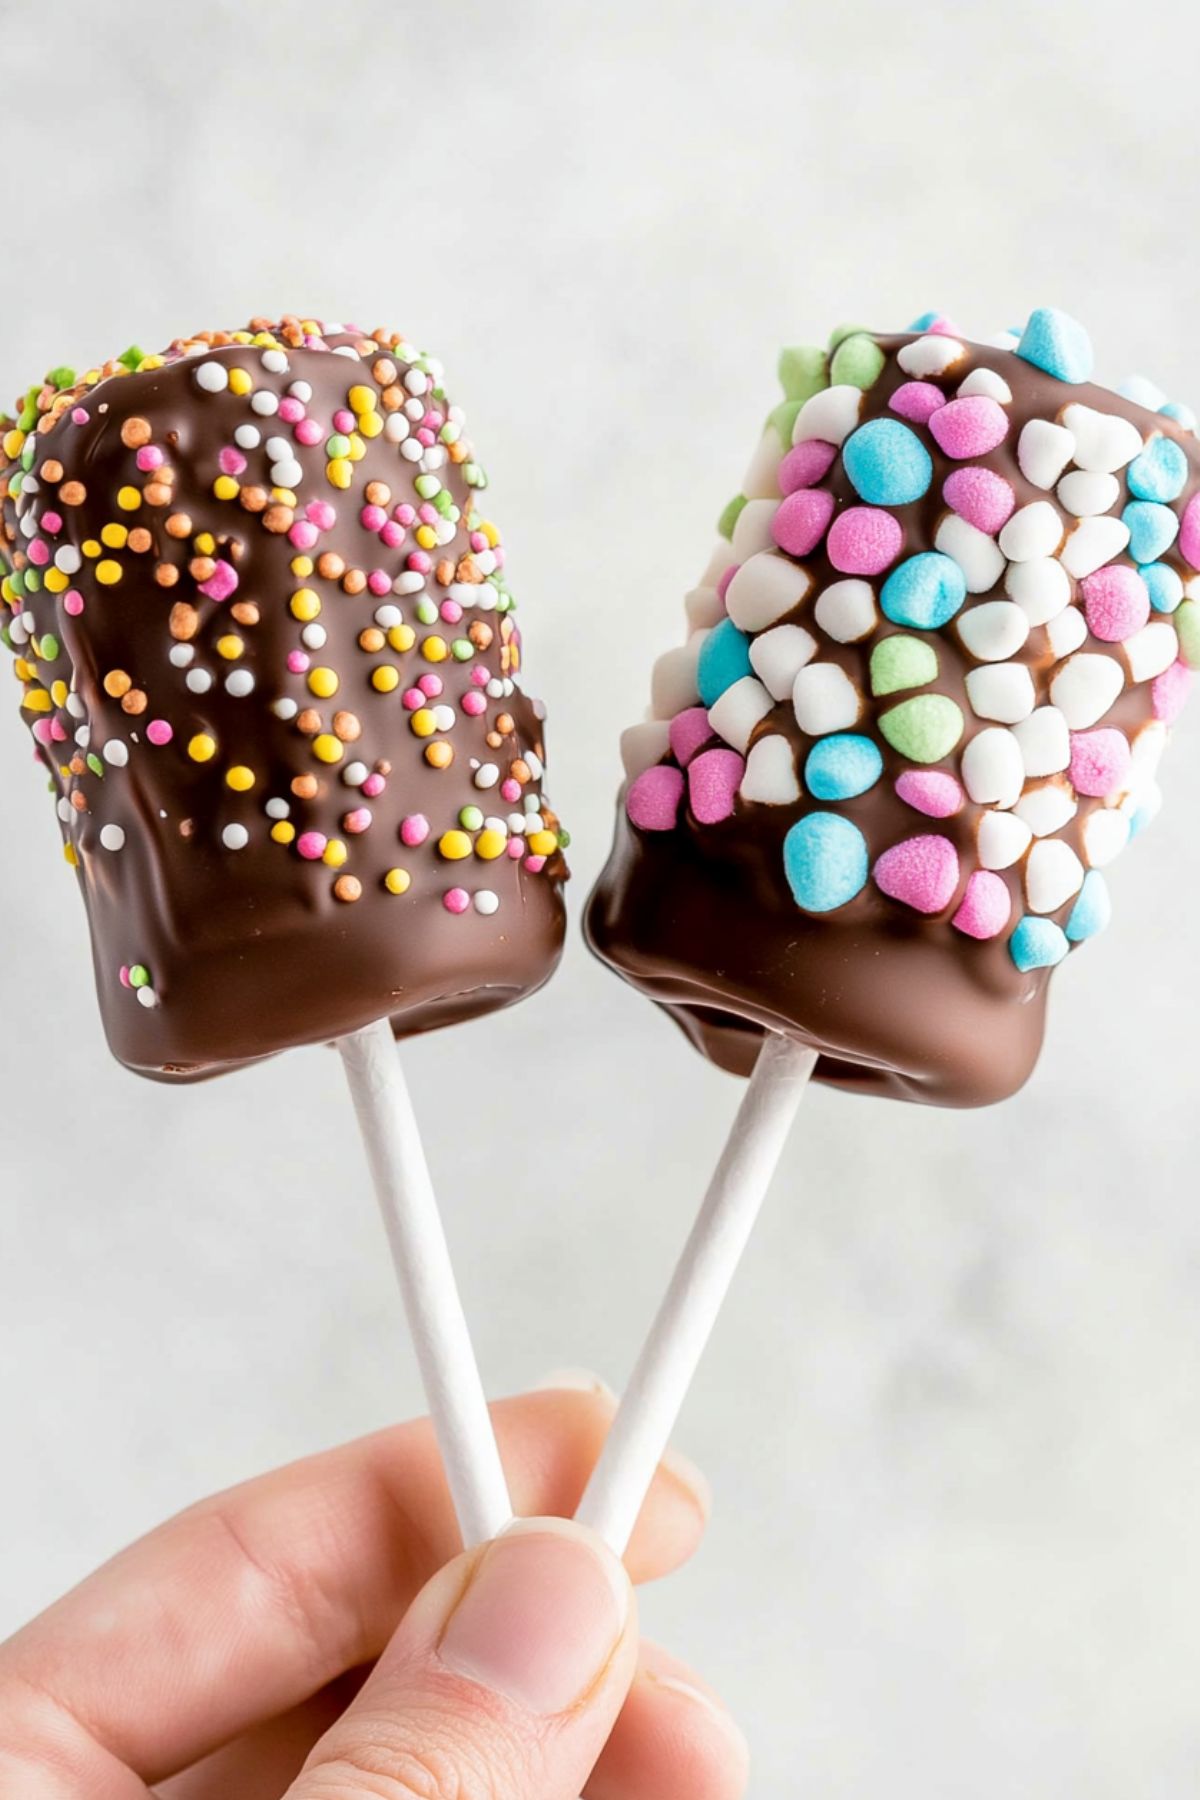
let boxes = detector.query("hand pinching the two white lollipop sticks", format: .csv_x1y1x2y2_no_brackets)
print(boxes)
0,1390,747,1800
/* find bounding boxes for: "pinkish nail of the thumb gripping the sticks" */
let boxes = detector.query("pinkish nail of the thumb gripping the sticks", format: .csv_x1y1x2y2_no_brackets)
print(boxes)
439,1519,630,1719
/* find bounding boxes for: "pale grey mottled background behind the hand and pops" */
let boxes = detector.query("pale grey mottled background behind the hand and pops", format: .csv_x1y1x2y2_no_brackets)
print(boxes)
0,0,1200,1800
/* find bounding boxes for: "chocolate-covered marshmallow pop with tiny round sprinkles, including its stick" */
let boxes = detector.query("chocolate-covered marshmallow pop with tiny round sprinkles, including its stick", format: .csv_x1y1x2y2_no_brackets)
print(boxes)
0,317,567,1534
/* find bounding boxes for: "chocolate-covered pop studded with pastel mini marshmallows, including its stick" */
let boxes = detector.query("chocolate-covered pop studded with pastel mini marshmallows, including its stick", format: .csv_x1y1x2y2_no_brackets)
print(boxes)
575,310,1200,1548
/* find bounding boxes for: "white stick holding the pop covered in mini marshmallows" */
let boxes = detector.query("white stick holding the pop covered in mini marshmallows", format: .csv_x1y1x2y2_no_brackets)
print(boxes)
576,1033,817,1553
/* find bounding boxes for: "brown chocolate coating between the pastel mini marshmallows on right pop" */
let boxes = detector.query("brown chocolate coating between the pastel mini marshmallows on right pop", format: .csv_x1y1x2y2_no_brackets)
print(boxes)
585,335,1200,1105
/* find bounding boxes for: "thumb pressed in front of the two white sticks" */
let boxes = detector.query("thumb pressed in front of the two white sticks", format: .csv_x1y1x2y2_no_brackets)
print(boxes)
288,1519,637,1800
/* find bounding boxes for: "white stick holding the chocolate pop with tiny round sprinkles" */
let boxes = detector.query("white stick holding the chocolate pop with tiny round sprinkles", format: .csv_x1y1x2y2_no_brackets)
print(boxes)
338,1019,513,1550
